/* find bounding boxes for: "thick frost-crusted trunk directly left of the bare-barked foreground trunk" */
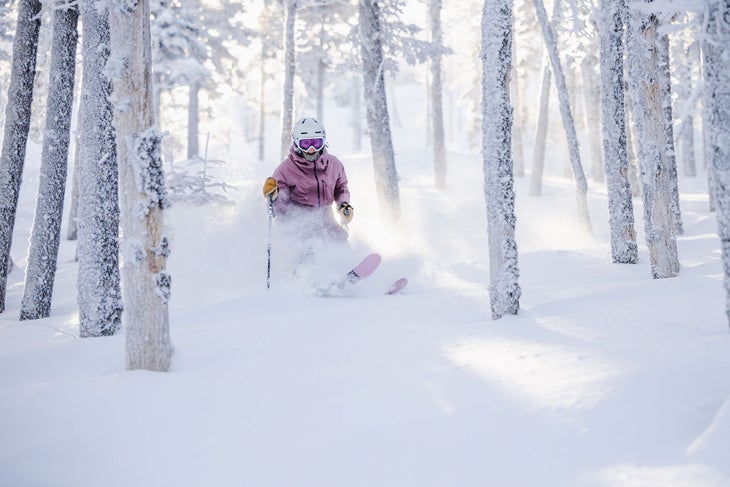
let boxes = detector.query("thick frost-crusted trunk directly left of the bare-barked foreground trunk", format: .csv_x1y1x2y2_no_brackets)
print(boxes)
78,0,122,337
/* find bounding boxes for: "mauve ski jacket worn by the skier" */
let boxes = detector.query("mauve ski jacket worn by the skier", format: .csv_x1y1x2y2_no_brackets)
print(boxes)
273,145,350,215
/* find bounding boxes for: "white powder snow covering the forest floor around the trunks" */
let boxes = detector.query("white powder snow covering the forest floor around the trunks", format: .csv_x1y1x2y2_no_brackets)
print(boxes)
0,86,730,487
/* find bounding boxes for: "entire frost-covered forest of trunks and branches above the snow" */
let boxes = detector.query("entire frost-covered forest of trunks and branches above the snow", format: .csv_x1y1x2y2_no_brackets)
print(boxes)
0,0,730,370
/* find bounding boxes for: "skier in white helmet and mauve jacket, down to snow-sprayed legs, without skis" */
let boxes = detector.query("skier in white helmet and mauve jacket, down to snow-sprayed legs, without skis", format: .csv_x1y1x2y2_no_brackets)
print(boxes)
263,117,354,242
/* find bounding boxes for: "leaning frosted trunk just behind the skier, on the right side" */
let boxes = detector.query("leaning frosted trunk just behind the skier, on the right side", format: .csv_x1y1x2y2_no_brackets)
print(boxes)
359,0,400,220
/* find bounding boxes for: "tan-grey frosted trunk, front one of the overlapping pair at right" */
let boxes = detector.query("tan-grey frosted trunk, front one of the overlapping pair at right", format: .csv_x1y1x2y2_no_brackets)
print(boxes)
627,1,679,279
